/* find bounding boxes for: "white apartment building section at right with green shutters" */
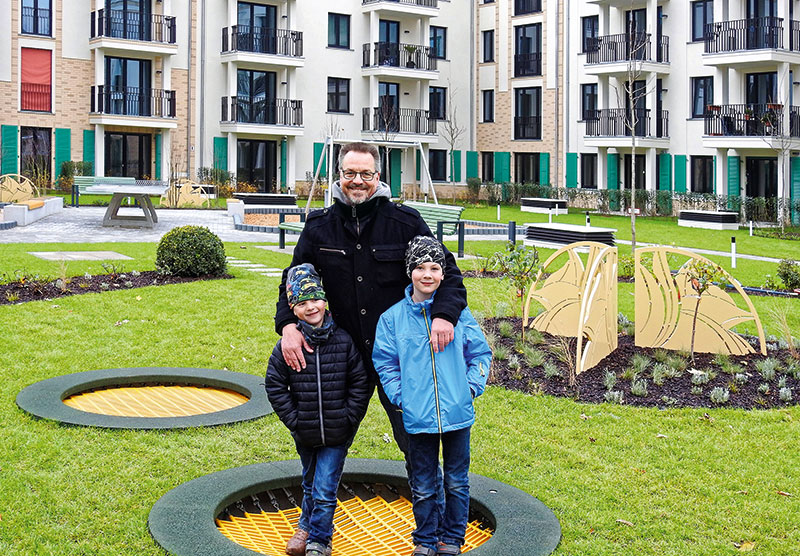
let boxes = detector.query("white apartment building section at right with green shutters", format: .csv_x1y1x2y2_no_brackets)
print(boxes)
564,0,800,217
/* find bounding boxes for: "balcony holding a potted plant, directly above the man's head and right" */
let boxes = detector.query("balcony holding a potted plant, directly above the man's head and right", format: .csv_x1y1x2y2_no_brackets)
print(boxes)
361,42,439,79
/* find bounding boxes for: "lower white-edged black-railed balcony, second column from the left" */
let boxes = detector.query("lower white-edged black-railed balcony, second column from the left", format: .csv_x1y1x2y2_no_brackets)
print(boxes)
220,96,303,135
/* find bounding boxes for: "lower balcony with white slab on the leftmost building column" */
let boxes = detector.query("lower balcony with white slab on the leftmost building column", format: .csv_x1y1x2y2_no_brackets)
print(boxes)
89,85,177,128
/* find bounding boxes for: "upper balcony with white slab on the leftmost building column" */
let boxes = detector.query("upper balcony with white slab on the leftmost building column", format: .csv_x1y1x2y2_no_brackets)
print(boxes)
89,10,178,54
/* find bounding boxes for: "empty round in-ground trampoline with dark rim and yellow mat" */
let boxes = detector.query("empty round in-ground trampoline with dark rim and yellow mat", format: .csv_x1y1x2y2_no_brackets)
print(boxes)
17,367,272,429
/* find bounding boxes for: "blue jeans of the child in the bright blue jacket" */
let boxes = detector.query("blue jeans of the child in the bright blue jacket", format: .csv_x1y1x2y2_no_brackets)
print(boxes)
408,427,470,550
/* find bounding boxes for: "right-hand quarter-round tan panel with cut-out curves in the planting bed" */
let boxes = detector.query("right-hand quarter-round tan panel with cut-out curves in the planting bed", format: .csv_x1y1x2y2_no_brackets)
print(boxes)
635,247,767,355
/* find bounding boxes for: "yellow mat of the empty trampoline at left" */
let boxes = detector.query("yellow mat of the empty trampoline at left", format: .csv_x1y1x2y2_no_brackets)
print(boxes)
64,385,250,417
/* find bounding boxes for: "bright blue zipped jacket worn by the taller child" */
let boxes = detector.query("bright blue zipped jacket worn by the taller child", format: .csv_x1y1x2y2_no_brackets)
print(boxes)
372,285,492,434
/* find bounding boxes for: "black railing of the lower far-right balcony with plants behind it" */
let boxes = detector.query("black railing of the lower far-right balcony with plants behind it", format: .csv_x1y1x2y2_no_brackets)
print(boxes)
703,104,794,137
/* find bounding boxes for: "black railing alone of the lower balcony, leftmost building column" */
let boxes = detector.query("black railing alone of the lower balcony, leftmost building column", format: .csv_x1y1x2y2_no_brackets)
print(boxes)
91,85,175,118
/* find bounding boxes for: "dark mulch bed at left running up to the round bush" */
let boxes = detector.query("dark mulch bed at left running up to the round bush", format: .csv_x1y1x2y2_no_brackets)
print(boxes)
0,270,233,305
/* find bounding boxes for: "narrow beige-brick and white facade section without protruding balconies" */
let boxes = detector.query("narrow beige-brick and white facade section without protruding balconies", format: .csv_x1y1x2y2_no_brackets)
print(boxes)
476,0,565,186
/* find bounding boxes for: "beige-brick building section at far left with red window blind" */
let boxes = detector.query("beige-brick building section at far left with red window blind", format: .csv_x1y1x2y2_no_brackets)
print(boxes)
0,0,197,185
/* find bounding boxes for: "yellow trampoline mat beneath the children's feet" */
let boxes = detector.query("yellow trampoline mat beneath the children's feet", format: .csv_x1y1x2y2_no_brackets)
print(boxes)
217,496,493,556
